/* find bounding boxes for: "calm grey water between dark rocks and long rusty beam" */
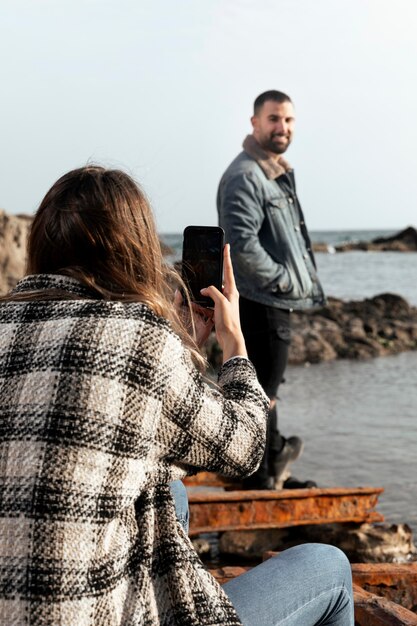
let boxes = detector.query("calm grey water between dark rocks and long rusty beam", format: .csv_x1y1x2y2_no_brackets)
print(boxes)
278,352,417,540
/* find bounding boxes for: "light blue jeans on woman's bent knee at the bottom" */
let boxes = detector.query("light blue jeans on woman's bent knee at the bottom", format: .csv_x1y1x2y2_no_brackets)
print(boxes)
223,543,354,626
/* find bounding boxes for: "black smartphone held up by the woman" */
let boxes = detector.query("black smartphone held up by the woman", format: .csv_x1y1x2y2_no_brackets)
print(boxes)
181,226,224,308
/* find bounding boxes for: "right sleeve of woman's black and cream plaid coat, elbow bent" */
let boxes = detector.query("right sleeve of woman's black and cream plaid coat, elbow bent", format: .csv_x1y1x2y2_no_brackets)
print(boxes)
156,337,269,477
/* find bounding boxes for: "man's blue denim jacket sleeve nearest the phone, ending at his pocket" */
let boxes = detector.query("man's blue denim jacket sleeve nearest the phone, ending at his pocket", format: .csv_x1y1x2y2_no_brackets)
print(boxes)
217,173,292,293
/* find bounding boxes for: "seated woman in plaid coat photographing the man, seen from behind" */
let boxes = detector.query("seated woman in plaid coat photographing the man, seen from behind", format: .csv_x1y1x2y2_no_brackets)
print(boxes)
0,166,352,626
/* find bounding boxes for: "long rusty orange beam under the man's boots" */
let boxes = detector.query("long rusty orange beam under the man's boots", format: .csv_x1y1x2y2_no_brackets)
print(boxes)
188,487,384,535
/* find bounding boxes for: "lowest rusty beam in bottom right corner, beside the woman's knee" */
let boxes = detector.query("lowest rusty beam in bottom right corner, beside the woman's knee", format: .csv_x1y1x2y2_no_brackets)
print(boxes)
353,584,417,626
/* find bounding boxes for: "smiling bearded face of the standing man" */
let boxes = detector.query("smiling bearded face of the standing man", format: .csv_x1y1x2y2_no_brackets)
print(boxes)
251,100,295,155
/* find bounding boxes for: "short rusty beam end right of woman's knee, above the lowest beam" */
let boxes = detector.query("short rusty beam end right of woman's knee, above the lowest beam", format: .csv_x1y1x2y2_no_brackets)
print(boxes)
352,563,417,610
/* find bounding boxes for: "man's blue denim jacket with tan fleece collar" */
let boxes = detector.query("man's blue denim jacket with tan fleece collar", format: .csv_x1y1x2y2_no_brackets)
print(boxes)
217,135,325,310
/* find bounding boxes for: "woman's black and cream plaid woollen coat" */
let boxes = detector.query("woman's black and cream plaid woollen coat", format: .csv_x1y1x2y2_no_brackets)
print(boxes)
0,275,267,626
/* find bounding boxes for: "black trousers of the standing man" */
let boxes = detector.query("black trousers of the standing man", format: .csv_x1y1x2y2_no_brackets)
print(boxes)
240,297,291,482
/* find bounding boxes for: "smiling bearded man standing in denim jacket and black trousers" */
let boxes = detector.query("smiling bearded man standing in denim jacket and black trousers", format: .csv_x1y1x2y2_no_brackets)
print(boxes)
217,91,325,489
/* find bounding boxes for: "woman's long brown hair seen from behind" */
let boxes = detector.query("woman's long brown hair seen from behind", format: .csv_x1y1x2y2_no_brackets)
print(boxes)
17,165,204,367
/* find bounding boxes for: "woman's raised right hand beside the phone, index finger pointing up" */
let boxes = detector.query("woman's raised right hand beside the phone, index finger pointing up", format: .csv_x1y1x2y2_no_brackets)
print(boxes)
201,244,247,361
